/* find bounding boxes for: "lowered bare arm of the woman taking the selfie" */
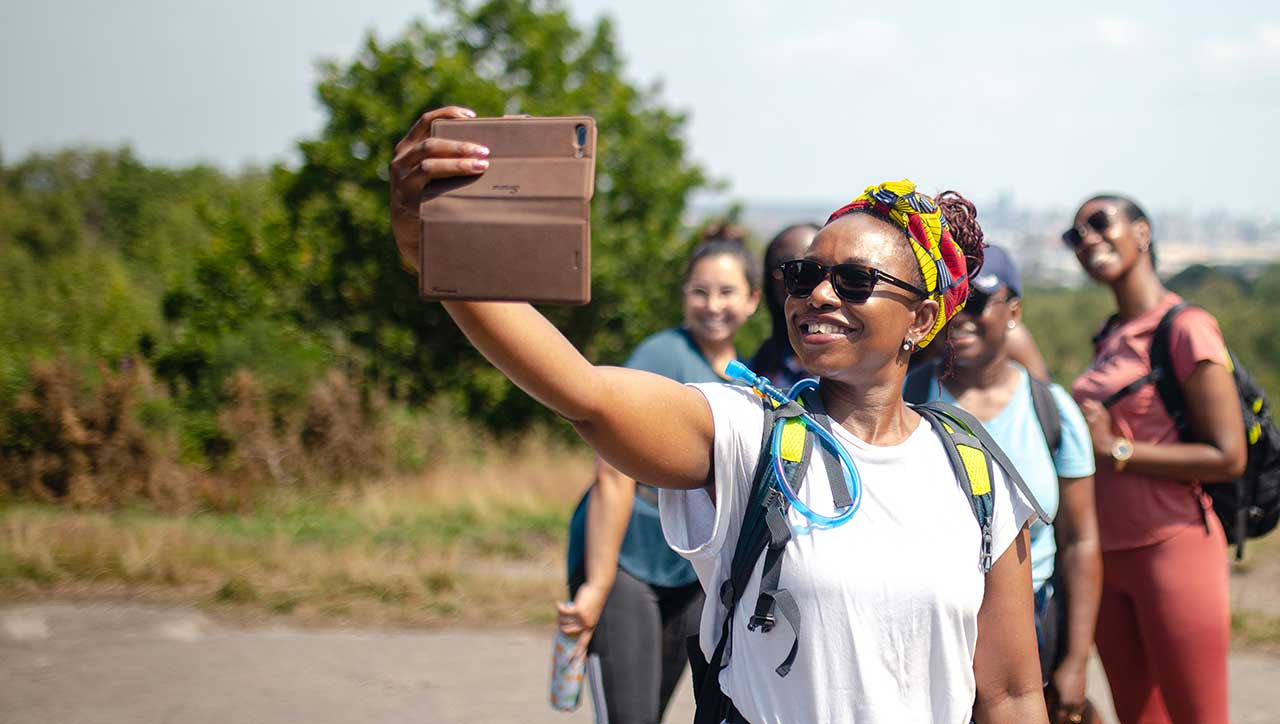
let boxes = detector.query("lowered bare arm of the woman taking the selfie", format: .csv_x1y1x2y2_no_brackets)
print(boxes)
973,528,1048,724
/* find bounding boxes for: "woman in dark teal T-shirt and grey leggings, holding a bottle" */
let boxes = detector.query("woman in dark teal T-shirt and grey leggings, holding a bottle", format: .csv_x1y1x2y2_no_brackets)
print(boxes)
558,237,760,724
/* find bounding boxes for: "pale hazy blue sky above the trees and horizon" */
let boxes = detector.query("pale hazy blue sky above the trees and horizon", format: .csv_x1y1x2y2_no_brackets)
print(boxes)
0,0,1280,214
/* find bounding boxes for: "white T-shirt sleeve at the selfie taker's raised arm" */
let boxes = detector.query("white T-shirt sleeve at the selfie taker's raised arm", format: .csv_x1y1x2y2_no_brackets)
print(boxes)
658,382,764,562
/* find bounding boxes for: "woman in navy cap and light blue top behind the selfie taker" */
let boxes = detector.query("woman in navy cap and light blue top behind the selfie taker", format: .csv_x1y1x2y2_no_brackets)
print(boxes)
904,247,1102,721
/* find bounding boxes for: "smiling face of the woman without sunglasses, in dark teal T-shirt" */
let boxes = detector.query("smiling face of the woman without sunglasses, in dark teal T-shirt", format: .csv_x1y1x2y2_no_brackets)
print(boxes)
685,253,760,345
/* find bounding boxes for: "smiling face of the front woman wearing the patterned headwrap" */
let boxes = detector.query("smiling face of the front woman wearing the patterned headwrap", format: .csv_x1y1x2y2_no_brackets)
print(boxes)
786,214,938,384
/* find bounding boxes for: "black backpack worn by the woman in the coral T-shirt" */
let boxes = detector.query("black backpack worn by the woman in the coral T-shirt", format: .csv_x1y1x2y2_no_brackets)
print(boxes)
1094,302,1280,560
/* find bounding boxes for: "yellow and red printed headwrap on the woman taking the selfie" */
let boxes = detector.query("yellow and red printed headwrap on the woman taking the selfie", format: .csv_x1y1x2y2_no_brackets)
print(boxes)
827,179,969,348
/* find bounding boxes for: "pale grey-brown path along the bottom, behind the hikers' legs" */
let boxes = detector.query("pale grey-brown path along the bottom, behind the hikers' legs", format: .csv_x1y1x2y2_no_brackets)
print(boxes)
0,604,1280,724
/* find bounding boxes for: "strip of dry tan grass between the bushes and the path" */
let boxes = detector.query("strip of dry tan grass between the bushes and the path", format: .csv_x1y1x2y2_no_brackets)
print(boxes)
0,439,591,624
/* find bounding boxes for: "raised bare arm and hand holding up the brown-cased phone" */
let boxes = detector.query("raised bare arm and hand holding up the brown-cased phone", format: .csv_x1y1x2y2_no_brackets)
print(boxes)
389,106,714,489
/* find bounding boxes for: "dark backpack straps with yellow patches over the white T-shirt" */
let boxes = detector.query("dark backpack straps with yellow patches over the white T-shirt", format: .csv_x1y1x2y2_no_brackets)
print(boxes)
689,390,1048,724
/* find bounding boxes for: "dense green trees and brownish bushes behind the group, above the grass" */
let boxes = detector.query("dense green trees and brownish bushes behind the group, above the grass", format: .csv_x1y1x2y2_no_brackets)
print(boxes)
0,0,1280,511
